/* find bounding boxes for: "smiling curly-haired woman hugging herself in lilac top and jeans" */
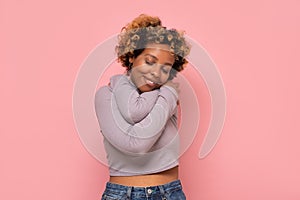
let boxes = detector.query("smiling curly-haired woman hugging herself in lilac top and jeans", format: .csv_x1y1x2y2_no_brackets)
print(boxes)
95,14,190,200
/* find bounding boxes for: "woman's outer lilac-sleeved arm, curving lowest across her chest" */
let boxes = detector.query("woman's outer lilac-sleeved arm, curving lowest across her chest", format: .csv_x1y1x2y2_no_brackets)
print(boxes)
95,87,177,154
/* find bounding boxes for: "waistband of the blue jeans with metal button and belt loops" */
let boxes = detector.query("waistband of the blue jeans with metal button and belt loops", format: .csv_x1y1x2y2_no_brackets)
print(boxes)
104,180,182,199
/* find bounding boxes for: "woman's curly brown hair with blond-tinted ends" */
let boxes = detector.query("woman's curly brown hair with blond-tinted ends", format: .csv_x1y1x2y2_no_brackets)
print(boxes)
116,14,190,80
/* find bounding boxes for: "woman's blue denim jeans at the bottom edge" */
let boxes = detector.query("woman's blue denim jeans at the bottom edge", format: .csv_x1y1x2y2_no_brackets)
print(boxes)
101,180,186,200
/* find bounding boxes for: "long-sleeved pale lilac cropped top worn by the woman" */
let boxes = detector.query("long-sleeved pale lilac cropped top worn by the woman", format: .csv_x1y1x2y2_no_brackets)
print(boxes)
95,75,179,176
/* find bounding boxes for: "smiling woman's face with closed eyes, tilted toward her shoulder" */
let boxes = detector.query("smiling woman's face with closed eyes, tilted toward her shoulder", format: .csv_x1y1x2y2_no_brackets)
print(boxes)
130,44,175,92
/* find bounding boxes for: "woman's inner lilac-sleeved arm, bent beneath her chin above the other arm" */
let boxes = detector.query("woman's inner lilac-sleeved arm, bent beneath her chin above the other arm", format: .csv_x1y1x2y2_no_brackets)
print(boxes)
113,76,159,124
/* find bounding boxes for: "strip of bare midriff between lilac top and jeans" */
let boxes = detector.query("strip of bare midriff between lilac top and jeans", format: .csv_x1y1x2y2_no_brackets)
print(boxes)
109,166,178,187
